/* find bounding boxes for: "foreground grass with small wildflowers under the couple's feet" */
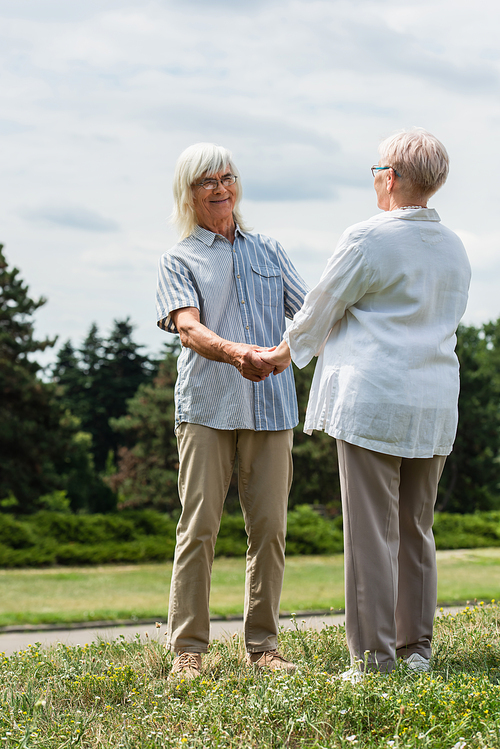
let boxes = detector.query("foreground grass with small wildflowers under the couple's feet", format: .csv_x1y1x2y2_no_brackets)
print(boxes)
0,604,500,749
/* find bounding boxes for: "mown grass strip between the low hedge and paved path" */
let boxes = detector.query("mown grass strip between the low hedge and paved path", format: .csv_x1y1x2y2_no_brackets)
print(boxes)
0,549,500,626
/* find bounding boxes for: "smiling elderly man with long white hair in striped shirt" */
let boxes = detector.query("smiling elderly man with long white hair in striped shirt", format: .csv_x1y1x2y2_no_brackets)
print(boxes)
157,143,307,679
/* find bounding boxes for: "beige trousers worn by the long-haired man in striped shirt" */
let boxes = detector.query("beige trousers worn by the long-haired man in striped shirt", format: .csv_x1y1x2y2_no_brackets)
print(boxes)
167,422,293,653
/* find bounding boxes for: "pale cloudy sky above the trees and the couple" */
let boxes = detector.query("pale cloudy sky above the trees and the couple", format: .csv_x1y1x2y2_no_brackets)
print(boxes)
0,0,500,362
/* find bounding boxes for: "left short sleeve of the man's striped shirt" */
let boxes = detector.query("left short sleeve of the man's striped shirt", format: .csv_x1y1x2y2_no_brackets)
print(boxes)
156,252,200,333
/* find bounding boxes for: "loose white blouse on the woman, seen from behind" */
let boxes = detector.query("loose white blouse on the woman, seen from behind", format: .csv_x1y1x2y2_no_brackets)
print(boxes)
284,208,470,458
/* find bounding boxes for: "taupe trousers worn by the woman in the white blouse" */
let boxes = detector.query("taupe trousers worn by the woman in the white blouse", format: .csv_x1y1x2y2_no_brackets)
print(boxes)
337,440,446,671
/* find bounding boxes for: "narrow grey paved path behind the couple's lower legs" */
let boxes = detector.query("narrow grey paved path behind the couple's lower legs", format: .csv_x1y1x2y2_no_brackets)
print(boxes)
0,606,464,655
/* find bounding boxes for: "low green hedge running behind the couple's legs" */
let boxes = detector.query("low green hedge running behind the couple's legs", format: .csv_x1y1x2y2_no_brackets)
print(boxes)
0,505,500,567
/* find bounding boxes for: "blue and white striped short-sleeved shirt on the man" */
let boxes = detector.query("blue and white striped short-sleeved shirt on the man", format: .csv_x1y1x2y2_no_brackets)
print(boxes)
157,226,307,431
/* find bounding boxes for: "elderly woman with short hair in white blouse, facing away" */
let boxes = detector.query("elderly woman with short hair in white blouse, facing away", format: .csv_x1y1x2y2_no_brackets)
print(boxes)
261,129,470,681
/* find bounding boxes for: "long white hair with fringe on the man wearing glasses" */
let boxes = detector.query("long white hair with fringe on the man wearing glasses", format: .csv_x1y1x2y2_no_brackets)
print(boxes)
170,143,249,240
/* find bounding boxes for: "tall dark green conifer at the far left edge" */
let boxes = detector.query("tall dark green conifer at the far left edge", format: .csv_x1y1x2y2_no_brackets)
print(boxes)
0,246,99,512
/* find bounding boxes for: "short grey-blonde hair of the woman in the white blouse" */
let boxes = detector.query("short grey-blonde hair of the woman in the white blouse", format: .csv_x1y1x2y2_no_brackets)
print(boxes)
378,127,450,198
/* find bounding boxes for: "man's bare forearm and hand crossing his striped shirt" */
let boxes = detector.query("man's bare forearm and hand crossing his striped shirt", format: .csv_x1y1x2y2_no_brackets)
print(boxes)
170,307,274,382
